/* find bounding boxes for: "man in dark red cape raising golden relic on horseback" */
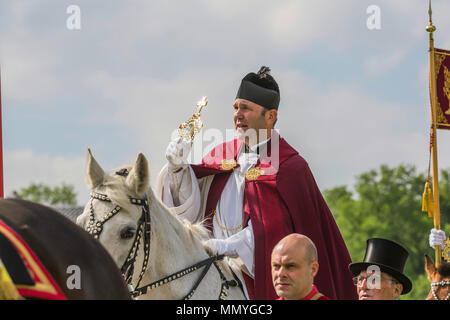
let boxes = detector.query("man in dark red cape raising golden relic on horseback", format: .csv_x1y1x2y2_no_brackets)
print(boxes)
157,67,356,300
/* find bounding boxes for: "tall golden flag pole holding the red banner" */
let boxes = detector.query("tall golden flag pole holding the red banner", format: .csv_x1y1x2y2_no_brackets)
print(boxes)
426,0,441,266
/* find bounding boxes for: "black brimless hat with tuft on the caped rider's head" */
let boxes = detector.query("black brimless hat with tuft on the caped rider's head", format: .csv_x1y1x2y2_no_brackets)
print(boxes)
236,66,280,110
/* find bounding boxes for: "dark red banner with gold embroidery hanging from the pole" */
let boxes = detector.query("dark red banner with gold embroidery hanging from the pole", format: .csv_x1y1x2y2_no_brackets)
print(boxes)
434,49,450,130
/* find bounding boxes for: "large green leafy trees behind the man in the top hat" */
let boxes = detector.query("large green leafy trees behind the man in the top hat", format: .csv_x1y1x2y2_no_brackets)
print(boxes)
324,165,450,299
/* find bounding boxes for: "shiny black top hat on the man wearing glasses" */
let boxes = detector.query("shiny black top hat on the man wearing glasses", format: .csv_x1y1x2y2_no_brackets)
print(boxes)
348,238,412,294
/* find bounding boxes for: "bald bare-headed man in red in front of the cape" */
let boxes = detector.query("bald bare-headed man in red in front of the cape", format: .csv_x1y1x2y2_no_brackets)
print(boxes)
272,233,330,300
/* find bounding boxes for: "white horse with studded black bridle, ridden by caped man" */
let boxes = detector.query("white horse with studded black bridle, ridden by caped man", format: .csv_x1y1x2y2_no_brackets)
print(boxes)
77,149,245,300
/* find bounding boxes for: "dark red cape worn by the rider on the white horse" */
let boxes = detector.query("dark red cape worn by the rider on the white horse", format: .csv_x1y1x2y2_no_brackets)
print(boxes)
192,137,357,300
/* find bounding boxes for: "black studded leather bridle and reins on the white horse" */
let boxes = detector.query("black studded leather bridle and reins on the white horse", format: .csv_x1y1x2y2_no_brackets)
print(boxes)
86,185,242,300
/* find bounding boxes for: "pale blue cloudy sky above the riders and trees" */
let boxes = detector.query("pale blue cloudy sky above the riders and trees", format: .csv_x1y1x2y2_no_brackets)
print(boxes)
0,0,450,204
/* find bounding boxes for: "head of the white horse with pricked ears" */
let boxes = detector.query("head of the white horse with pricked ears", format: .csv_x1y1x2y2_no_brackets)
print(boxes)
77,150,149,267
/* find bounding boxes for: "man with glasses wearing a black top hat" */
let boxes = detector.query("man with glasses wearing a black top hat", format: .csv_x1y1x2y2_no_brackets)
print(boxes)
349,238,412,300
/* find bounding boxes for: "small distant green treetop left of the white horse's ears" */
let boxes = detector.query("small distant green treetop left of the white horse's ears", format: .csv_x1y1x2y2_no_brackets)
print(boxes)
15,183,77,206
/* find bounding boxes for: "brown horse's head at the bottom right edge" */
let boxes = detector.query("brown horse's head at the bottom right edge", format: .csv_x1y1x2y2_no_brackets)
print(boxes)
425,255,450,300
